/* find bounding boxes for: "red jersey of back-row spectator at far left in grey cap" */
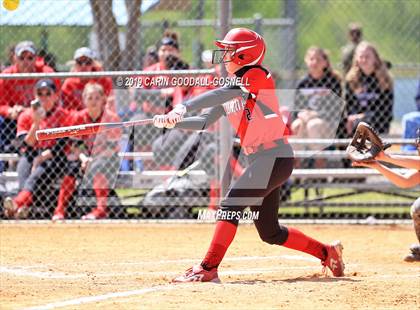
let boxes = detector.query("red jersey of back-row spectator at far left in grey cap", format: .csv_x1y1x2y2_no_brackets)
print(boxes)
0,63,60,116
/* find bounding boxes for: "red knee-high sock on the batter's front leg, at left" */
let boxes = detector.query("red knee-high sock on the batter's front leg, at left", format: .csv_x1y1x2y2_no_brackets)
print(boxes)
201,221,238,270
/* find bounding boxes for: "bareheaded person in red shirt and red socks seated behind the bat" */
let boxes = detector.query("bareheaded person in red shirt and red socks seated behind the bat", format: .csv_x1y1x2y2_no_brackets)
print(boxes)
52,83,121,221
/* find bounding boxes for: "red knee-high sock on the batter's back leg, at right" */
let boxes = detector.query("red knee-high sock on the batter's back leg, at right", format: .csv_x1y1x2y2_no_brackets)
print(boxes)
282,227,327,260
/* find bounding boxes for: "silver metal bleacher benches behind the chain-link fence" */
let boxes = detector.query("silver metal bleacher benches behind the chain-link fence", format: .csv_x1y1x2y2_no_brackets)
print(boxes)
0,139,418,214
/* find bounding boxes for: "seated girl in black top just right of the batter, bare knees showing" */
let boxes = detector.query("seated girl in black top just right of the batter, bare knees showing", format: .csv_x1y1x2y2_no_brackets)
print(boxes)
292,47,342,147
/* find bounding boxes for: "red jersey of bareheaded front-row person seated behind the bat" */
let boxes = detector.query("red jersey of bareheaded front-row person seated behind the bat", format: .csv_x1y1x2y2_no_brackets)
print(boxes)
73,109,122,155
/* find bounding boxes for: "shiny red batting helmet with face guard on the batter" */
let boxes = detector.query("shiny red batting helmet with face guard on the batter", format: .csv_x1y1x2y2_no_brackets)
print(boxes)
212,28,265,66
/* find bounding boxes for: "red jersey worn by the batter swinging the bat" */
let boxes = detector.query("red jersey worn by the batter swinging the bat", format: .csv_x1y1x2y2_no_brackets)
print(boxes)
223,66,289,147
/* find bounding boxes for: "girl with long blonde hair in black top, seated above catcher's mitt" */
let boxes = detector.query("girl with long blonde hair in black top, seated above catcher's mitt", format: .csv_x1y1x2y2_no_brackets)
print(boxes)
345,42,394,137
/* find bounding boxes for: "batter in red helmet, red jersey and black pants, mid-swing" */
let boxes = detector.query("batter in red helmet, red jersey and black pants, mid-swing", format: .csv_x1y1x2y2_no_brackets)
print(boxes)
154,28,344,282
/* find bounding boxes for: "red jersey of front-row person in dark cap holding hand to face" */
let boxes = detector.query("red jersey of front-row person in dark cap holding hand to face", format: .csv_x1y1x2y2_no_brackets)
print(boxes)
16,106,72,149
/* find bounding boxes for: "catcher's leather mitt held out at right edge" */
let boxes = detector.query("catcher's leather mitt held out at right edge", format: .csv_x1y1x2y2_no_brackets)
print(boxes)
346,122,390,162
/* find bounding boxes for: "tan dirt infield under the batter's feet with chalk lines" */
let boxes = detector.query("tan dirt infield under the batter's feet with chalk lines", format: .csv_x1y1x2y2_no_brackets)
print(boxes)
0,223,420,310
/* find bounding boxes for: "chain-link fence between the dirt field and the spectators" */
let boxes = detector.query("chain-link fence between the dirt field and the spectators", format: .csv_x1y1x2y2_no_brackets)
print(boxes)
0,0,420,219
